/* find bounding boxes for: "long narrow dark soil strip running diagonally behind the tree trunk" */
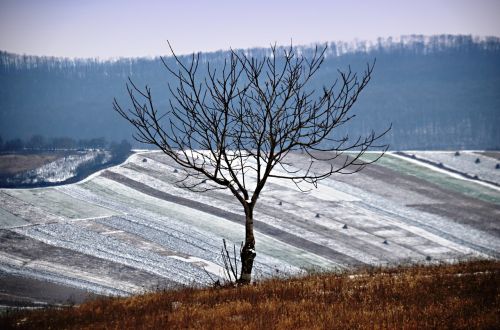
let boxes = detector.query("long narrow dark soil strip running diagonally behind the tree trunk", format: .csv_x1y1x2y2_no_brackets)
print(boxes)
101,171,363,266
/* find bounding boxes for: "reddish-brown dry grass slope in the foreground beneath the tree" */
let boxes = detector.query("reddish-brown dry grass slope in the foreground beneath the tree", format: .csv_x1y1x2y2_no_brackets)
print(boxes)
0,261,500,329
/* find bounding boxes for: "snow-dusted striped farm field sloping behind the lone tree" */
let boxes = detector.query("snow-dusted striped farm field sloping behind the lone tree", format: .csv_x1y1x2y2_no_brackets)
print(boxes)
0,152,500,304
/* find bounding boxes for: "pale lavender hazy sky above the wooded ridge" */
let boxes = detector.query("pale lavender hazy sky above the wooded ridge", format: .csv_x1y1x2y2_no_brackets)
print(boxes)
0,0,500,58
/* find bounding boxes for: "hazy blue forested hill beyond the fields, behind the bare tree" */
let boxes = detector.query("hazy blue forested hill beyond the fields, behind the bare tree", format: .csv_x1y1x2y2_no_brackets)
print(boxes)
0,35,500,149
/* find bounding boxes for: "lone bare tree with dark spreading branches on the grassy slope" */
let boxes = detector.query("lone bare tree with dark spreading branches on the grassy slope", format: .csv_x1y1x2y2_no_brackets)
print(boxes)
113,44,390,283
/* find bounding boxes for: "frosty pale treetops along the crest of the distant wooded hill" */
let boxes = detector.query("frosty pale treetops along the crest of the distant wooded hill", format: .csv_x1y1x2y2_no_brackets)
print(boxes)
0,34,500,73
